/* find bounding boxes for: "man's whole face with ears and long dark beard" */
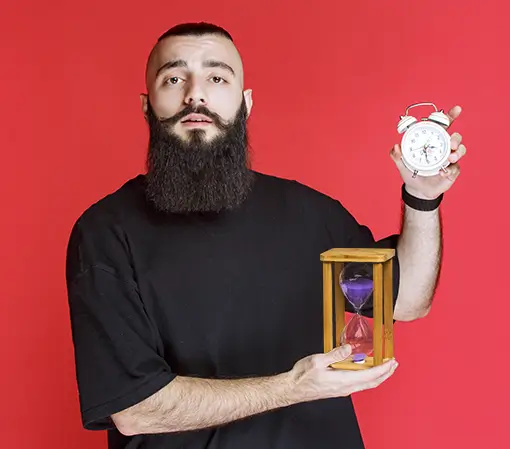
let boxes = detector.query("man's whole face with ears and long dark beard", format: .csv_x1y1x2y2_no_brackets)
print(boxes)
142,32,254,214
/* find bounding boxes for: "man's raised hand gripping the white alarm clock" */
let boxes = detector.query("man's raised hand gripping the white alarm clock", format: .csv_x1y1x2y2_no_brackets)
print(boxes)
390,106,466,199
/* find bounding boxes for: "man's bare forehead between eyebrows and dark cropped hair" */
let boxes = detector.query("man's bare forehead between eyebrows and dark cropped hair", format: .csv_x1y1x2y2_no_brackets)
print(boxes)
147,35,242,82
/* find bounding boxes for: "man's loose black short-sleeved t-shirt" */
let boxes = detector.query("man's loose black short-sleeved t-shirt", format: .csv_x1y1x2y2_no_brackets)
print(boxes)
67,173,399,449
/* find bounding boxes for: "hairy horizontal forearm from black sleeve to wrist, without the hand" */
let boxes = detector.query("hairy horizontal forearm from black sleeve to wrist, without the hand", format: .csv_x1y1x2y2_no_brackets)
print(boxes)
112,374,294,435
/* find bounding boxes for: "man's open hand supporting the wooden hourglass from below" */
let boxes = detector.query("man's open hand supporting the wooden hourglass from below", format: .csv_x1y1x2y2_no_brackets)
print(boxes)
289,345,398,402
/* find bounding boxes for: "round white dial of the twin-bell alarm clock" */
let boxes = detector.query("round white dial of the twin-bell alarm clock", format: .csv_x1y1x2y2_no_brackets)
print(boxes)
402,122,450,171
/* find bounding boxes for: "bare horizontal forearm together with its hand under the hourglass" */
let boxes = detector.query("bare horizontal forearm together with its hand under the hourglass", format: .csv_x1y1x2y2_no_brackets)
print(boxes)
112,345,398,435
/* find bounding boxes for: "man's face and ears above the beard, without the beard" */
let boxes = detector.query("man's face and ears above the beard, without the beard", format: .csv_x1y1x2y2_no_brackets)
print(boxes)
142,35,252,141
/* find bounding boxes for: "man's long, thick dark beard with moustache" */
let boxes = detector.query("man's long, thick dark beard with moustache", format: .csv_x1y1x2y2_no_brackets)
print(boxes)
145,99,254,214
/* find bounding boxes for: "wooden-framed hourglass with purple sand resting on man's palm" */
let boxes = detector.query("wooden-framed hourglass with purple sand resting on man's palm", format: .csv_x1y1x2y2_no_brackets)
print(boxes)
320,248,395,370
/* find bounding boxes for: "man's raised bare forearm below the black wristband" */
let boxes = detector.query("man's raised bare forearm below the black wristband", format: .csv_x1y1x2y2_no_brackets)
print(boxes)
394,201,442,321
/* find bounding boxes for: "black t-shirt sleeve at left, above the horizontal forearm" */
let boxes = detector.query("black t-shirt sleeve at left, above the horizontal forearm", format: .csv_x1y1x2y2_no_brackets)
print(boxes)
66,214,175,430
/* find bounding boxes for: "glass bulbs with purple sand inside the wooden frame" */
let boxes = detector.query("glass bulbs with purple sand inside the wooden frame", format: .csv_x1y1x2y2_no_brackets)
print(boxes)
337,262,374,363
